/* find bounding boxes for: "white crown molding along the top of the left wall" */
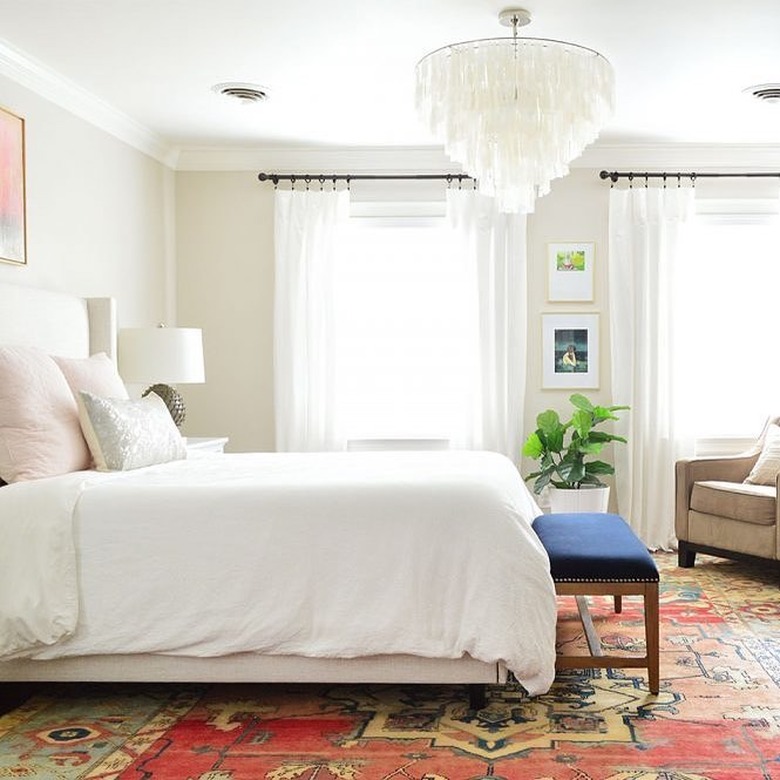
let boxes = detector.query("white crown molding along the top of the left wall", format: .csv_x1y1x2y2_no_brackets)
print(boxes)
0,40,177,168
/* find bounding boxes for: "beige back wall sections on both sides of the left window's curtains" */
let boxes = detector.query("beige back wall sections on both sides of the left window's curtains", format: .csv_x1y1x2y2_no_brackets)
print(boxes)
176,165,617,458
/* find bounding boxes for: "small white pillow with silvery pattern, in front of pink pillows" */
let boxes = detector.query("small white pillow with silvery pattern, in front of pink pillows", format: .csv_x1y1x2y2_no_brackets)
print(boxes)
78,390,187,471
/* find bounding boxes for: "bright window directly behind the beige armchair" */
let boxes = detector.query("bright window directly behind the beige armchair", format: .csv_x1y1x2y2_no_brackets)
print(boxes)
675,200,780,439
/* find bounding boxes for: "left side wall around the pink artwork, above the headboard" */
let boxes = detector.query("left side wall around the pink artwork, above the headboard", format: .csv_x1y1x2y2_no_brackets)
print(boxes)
0,77,173,325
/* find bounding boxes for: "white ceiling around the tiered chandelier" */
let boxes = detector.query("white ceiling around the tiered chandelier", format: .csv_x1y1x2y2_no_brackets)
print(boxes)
0,0,780,158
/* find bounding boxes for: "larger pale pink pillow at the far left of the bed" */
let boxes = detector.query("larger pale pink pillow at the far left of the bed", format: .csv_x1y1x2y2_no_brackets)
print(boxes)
0,347,91,482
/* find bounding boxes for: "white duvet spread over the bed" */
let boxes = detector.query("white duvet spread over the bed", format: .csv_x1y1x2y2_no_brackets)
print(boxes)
0,452,556,694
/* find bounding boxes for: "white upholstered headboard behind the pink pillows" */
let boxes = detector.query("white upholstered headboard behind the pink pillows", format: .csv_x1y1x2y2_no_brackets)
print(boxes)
0,282,116,360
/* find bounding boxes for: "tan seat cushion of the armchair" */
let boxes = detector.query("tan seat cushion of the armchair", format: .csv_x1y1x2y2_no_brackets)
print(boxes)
690,480,776,525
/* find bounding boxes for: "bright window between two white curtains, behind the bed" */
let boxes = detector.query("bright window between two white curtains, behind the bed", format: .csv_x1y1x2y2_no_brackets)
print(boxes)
335,209,473,442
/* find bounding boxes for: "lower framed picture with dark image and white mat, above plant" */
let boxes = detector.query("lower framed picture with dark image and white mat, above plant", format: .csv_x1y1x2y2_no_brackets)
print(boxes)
542,314,599,389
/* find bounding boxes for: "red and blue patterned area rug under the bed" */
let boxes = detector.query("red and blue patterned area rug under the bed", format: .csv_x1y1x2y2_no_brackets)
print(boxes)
0,555,780,780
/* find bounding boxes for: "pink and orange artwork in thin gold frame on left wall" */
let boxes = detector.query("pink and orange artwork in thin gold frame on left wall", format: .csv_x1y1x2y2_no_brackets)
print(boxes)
0,108,27,265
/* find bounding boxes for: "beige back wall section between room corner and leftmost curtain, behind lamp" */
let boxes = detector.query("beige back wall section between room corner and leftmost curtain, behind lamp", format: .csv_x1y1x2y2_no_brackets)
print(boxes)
176,172,274,452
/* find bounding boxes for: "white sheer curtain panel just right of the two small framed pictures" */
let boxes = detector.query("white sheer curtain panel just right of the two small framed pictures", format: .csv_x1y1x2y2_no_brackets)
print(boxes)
609,186,693,549
